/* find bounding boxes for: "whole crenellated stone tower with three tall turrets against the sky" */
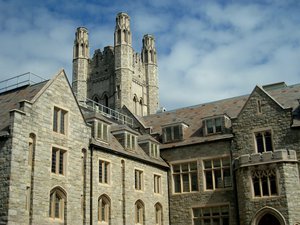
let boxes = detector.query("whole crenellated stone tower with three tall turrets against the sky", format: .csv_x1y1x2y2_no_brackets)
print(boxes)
73,13,159,116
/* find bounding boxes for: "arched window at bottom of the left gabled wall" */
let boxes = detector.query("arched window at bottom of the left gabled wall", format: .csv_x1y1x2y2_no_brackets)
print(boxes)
49,187,67,220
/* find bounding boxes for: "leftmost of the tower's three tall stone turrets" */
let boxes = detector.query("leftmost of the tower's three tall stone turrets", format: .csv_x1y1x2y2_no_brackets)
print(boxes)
72,27,90,102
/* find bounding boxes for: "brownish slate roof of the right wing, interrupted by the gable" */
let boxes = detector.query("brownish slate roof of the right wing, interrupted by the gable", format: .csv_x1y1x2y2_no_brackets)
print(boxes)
142,84,300,149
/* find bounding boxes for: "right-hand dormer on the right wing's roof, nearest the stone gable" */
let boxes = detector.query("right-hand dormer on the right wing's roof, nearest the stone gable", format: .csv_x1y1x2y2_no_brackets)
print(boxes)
204,115,231,135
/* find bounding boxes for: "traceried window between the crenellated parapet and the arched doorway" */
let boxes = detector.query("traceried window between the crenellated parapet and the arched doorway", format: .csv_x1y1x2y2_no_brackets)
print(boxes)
252,169,278,197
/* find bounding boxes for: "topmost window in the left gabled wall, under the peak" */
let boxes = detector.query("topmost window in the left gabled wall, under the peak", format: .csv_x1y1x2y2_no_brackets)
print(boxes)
52,106,69,135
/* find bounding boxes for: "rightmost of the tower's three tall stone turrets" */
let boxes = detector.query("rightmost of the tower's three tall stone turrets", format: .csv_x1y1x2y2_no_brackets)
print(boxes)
142,34,159,114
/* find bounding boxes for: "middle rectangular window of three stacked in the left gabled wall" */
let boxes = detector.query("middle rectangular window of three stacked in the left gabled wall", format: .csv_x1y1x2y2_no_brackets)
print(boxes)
51,146,67,176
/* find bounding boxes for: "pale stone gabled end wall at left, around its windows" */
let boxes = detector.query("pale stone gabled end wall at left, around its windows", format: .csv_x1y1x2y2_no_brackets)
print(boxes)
9,73,91,225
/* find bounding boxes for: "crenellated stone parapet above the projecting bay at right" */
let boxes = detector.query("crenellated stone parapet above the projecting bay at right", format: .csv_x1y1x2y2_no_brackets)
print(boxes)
235,149,297,169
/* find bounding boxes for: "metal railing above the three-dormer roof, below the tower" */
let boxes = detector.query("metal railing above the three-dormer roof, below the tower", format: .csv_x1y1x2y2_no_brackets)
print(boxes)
79,98,133,127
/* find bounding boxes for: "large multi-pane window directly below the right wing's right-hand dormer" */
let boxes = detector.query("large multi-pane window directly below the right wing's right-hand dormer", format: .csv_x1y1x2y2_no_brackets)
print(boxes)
203,157,232,190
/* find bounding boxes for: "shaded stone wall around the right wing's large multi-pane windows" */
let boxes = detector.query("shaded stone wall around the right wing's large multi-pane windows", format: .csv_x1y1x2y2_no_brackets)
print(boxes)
161,140,237,225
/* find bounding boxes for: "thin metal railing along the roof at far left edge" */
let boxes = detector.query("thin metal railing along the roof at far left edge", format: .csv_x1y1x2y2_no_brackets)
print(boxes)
0,72,46,93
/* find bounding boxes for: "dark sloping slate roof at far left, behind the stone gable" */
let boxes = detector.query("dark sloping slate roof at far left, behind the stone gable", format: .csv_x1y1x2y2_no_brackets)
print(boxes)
0,81,47,132
